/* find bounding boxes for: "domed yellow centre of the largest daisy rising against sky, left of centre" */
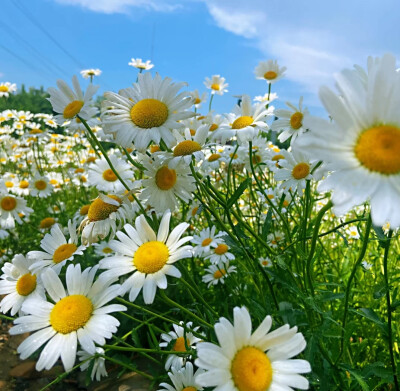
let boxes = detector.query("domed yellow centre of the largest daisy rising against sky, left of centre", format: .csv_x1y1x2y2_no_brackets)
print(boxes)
131,99,168,129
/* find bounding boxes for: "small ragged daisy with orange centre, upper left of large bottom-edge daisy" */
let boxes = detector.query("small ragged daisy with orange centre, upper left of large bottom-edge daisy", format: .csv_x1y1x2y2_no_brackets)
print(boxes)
159,322,201,370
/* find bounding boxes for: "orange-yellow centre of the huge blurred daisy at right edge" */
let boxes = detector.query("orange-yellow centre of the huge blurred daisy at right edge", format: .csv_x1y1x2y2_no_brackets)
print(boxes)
354,125,400,175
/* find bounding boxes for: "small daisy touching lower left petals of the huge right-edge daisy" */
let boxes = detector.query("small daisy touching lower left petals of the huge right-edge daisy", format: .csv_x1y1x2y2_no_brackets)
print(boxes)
274,149,318,197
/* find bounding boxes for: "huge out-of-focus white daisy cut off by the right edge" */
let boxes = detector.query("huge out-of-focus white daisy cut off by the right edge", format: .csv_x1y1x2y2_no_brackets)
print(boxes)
299,54,400,228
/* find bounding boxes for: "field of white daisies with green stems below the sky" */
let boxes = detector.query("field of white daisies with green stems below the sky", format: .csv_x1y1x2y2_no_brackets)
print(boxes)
0,54,400,391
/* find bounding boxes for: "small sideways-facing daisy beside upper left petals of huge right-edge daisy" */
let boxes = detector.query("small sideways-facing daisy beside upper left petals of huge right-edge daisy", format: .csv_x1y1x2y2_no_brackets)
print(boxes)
271,97,308,143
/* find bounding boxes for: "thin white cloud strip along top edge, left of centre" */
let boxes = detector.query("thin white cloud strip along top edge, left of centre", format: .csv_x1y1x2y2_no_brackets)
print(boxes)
55,0,181,14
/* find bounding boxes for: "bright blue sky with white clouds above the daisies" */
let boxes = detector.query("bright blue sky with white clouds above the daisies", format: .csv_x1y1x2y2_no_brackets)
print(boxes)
0,0,400,114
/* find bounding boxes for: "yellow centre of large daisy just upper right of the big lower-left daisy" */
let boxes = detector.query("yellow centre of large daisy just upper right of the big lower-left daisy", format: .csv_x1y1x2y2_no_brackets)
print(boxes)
133,240,169,274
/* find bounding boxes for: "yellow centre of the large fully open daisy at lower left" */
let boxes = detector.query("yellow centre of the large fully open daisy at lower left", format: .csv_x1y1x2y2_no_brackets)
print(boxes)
50,295,93,334
